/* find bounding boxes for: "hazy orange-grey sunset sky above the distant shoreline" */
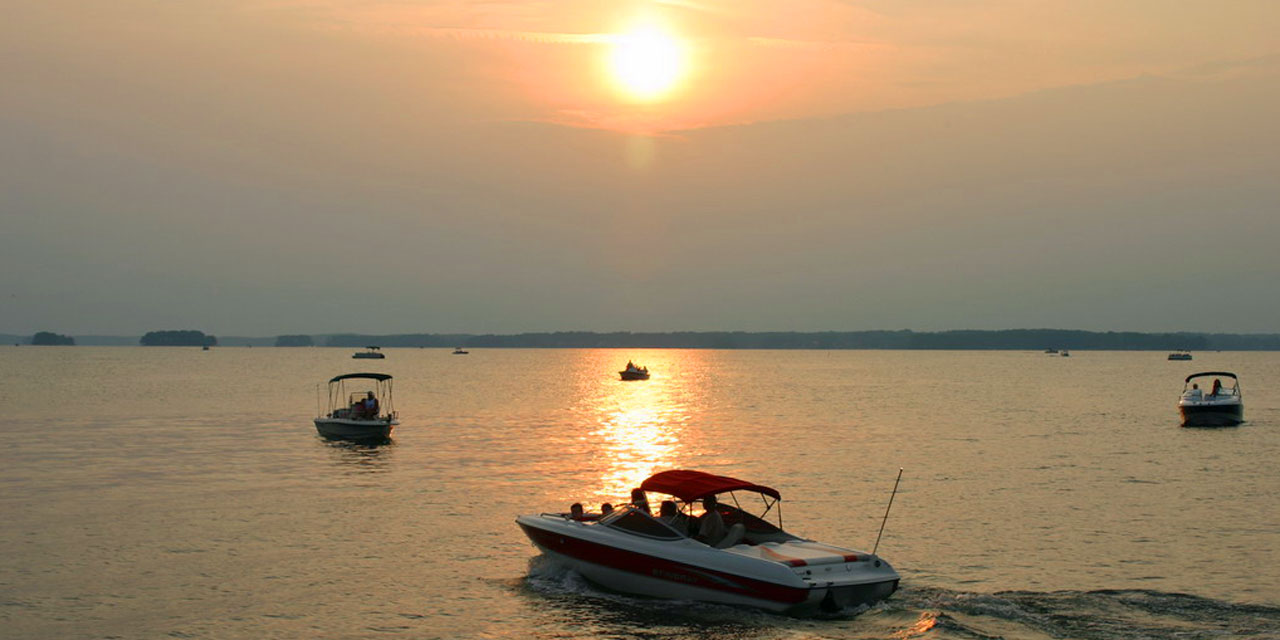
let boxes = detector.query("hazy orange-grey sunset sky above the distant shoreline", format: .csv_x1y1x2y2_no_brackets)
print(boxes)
0,0,1280,335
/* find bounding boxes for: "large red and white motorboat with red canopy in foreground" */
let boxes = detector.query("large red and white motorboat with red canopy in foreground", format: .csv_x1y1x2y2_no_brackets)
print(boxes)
516,470,900,616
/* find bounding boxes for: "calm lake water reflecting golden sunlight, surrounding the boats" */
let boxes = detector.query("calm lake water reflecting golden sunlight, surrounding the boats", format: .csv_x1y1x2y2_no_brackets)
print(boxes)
0,347,1280,639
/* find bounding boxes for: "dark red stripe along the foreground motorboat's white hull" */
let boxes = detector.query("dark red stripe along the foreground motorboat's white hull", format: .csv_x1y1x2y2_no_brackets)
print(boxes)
520,524,809,604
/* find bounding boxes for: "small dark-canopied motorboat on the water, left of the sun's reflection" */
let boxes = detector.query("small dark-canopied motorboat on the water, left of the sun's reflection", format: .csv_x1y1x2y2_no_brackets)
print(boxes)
315,374,399,440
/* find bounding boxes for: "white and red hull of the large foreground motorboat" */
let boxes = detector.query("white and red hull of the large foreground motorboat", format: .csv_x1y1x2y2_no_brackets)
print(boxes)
517,516,899,616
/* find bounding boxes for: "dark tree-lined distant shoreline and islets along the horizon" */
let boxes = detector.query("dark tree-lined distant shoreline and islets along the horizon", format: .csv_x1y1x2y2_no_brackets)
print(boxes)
0,329,1280,351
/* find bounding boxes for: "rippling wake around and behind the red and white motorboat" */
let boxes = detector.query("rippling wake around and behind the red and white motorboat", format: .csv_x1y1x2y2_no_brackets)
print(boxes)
524,556,1280,640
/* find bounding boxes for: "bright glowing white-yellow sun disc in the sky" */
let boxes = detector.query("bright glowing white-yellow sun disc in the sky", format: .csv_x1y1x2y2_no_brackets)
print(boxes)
609,27,685,100
